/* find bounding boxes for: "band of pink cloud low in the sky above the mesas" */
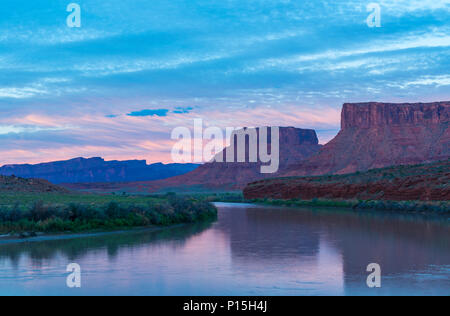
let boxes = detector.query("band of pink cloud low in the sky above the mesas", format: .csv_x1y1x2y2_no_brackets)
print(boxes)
0,105,340,164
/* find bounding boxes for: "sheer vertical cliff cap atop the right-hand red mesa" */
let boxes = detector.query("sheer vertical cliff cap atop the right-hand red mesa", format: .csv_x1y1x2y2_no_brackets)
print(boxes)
341,101,450,130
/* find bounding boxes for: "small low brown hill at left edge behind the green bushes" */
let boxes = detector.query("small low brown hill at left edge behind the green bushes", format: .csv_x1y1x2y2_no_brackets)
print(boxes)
0,176,70,193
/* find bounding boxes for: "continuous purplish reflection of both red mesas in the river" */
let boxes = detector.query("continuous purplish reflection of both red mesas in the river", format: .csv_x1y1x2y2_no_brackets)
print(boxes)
218,207,450,284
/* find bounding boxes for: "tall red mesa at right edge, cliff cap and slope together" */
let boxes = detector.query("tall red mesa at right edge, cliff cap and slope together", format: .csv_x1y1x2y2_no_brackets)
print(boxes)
285,102,450,176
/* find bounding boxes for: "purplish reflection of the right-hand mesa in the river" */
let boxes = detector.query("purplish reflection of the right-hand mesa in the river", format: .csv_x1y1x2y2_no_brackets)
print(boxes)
325,212,450,284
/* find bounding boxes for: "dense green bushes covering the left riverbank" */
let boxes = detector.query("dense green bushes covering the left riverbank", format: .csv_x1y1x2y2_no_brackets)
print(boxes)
0,195,217,237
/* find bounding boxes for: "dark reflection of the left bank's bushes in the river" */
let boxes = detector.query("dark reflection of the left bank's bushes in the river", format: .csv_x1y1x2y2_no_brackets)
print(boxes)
0,223,211,267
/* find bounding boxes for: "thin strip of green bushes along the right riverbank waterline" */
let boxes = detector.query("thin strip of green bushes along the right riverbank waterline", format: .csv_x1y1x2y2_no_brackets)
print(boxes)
246,199,450,214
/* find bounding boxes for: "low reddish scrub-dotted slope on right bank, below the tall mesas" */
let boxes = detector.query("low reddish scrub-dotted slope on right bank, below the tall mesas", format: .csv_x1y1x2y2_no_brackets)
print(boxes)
244,160,450,201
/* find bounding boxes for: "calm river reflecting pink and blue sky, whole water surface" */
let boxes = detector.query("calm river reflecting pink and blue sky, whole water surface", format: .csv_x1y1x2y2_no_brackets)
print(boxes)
0,203,450,295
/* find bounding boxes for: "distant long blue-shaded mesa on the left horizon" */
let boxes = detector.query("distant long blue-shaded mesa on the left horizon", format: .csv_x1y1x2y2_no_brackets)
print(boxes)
0,158,198,183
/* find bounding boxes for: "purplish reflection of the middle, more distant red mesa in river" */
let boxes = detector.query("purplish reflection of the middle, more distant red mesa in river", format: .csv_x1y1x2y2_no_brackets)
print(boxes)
217,207,320,263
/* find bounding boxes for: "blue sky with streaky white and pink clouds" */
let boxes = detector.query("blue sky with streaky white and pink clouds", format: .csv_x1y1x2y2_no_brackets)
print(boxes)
0,0,450,165
